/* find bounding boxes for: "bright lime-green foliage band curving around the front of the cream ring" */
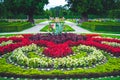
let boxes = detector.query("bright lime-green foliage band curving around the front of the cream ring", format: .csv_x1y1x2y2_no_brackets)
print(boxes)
0,52,120,78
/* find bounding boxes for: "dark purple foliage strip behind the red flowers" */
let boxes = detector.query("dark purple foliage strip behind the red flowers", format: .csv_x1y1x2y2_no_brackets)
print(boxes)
29,33,86,44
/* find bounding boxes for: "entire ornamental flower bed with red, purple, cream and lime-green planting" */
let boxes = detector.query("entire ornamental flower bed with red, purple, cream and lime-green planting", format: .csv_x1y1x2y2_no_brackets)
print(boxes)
0,33,120,77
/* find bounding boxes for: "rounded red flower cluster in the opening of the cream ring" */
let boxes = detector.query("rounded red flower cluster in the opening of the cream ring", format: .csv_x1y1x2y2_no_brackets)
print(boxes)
43,42,72,57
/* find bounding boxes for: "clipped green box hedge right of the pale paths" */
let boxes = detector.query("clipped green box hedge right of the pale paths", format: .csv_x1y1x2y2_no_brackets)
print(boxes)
80,22,120,32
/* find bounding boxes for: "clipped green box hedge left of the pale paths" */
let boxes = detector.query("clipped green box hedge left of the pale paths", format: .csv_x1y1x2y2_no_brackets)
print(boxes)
0,22,32,32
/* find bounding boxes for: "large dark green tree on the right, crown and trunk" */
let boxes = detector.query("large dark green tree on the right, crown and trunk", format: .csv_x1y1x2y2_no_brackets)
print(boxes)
66,0,119,22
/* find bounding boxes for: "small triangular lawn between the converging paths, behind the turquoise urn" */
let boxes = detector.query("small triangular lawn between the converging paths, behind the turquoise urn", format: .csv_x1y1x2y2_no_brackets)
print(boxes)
40,25,75,32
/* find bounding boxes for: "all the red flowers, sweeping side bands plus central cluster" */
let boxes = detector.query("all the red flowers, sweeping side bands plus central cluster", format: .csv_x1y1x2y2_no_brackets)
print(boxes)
0,34,120,57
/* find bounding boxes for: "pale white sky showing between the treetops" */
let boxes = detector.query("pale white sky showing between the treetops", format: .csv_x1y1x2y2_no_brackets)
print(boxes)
44,0,67,10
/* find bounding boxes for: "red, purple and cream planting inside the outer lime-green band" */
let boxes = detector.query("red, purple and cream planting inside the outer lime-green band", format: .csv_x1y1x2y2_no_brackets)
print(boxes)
0,33,120,68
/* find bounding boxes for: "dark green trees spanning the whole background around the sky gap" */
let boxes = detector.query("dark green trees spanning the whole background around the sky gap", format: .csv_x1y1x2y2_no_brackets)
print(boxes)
0,0,120,23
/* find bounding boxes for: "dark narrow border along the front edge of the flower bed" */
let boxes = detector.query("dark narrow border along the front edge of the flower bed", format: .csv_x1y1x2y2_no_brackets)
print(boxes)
0,71,120,79
